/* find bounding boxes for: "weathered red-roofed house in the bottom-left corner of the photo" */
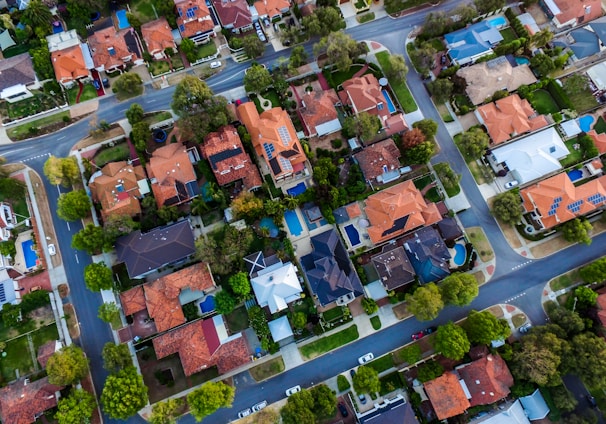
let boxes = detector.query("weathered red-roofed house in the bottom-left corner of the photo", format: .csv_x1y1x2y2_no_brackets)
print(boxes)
0,377,63,424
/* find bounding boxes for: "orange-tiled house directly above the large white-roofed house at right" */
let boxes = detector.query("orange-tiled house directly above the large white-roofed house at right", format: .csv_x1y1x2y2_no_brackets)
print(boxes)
475,94,549,144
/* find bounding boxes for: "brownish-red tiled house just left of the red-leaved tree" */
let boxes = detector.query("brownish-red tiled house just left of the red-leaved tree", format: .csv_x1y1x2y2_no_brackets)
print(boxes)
353,138,401,184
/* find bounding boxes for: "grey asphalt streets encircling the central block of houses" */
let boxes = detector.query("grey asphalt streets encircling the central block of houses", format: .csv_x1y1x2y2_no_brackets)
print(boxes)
0,2,606,423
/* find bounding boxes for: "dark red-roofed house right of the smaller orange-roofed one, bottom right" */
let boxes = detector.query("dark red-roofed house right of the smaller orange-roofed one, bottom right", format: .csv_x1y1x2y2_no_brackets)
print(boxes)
457,355,513,406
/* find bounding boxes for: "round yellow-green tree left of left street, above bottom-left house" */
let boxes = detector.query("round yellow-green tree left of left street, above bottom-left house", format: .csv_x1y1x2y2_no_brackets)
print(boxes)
46,345,88,386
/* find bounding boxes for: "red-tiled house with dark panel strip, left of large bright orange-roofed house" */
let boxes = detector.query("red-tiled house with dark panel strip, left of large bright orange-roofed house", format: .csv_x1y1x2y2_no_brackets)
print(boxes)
200,125,263,191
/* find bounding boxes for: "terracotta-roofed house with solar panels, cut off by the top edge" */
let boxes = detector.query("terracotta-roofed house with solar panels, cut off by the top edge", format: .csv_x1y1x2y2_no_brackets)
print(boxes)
174,0,215,44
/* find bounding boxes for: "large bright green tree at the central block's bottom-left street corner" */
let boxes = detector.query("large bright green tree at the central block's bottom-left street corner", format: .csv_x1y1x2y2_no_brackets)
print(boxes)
101,367,147,420
